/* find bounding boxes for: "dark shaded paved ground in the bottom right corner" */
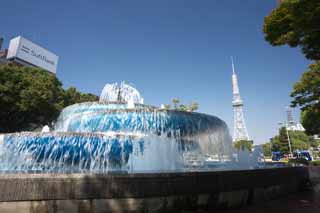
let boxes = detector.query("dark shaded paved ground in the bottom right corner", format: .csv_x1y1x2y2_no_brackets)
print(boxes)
214,192,320,213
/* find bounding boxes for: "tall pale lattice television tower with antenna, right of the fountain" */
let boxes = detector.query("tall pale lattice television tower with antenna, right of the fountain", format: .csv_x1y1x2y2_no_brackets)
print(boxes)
231,57,250,141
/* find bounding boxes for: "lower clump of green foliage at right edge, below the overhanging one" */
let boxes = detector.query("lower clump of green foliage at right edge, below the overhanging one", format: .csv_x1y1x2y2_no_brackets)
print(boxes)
291,61,320,135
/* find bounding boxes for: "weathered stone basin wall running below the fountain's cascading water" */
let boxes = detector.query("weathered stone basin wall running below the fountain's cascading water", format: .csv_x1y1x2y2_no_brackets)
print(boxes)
0,167,309,213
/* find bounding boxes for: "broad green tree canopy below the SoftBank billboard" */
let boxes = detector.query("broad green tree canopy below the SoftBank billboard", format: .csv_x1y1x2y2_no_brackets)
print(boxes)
0,65,98,132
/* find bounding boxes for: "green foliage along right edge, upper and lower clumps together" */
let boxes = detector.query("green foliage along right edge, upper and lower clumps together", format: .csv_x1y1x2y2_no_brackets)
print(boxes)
263,0,320,135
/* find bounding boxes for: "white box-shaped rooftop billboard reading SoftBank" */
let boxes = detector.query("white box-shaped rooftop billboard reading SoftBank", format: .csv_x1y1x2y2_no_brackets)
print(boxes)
7,36,59,73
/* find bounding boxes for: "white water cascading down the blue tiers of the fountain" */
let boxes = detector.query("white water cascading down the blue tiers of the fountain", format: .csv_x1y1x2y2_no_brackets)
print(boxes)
0,83,232,173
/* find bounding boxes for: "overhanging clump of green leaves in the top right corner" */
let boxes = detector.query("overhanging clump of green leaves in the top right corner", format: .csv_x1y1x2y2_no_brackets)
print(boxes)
263,0,320,60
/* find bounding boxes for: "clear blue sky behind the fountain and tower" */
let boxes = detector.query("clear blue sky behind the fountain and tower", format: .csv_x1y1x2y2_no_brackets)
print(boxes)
0,0,310,144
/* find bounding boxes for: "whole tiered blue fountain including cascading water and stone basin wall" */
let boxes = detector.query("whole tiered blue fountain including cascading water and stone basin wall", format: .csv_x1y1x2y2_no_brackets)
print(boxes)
0,83,315,213
